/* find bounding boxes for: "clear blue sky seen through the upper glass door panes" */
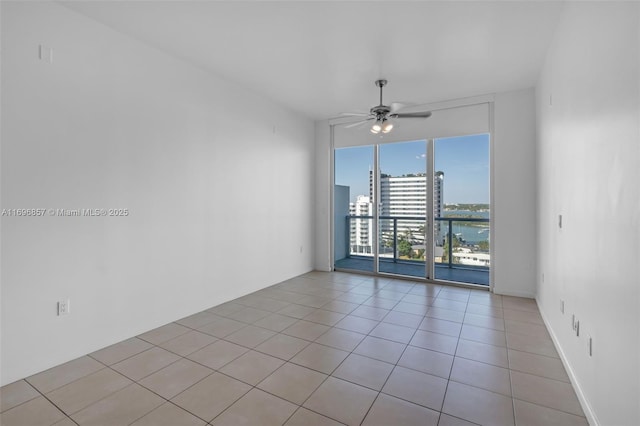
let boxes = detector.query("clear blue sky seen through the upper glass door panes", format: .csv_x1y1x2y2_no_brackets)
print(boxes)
335,134,489,204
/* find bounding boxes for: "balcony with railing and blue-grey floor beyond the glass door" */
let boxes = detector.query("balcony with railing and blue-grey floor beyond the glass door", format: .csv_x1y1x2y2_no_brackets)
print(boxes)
335,216,490,286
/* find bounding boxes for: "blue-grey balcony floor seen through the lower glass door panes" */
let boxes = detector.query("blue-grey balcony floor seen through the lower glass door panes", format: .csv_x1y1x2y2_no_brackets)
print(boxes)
335,256,489,286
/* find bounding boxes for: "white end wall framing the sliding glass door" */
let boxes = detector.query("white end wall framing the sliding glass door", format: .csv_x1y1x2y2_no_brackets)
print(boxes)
315,89,536,297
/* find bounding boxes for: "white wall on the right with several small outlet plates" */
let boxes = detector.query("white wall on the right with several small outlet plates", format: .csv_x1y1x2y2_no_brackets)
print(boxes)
537,2,640,425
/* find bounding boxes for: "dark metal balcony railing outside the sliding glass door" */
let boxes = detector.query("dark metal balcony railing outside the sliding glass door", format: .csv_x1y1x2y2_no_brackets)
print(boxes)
346,215,490,270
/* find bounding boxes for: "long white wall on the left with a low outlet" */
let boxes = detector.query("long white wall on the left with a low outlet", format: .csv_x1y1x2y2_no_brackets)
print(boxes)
1,2,315,384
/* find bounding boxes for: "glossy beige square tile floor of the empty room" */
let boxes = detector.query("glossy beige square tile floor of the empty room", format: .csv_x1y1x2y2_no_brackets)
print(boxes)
0,272,587,426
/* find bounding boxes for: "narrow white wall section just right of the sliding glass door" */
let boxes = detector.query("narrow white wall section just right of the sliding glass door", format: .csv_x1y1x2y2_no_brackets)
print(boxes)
491,89,536,297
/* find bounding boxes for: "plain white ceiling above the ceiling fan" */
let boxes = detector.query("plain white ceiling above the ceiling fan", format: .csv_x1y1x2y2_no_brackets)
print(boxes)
58,0,562,119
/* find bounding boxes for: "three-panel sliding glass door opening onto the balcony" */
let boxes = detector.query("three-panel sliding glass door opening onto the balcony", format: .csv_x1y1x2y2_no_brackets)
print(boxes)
334,134,490,285
